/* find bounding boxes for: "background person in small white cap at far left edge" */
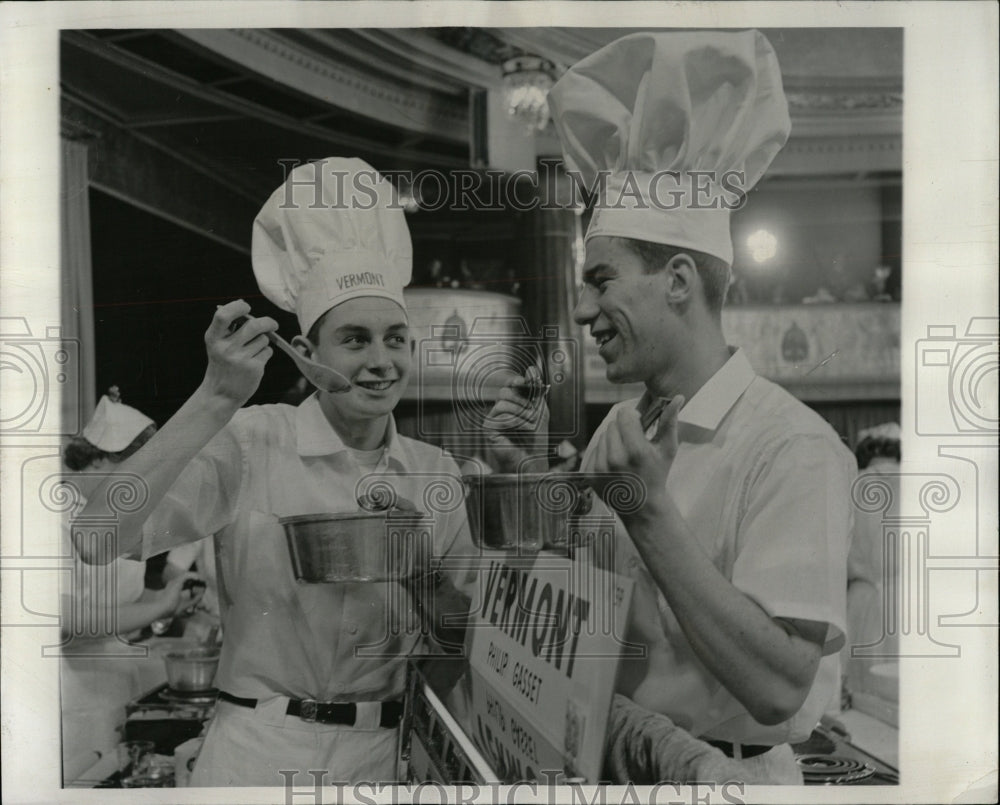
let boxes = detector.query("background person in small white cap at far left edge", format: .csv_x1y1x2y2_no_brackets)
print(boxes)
60,386,202,782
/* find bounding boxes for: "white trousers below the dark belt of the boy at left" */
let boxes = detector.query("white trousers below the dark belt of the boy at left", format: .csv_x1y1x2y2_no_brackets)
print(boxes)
190,698,399,791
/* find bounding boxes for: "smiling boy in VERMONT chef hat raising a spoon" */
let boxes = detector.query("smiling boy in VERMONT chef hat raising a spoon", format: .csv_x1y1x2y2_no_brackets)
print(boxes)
74,158,471,786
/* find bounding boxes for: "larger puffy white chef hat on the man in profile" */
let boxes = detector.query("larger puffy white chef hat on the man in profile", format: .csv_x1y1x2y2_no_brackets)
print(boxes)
549,31,791,265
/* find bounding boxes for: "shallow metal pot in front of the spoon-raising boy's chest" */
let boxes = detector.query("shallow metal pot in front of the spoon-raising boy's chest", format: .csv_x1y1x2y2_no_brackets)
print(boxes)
279,511,432,584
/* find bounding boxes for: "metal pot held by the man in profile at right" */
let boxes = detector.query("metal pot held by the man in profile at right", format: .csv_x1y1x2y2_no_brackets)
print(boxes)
462,472,594,551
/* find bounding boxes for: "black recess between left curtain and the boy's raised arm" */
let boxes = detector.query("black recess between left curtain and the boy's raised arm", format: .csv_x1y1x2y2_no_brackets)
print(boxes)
90,190,298,425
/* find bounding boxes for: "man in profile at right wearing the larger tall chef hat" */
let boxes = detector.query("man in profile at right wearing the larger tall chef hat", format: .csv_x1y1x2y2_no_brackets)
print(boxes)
498,31,854,783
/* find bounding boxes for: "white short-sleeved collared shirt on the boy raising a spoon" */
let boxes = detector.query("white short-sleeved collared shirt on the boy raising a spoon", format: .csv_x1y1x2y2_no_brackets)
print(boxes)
143,395,474,701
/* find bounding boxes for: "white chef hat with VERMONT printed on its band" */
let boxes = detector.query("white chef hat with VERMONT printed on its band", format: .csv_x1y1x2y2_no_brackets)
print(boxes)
251,157,413,334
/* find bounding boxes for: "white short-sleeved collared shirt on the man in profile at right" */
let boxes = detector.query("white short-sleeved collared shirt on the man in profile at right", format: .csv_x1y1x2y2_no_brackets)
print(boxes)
583,350,856,745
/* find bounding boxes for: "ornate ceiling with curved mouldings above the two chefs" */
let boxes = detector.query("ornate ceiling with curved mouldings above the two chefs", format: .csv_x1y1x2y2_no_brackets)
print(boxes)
61,28,903,248
